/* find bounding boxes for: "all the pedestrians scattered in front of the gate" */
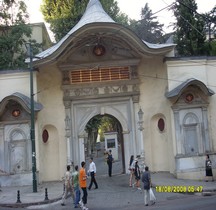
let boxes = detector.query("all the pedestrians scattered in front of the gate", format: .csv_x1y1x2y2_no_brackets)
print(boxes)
61,151,213,210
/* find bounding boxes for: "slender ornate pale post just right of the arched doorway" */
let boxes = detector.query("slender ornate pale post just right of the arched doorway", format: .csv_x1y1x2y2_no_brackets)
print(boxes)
138,108,145,170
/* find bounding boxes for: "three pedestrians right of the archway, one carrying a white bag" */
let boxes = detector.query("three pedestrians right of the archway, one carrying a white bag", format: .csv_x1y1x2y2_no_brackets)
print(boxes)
129,155,156,206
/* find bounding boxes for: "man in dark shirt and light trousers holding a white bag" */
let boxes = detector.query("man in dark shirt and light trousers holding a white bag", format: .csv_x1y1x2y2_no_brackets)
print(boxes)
142,166,155,206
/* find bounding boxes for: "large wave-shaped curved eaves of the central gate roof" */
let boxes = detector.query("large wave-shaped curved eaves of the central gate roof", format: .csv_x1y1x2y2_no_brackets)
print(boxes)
26,22,175,66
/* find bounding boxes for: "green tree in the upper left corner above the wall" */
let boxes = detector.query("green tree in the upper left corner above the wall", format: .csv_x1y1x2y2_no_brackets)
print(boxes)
0,0,31,70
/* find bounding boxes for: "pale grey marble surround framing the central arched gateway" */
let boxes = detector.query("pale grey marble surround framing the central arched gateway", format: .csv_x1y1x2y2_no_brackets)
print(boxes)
65,97,137,173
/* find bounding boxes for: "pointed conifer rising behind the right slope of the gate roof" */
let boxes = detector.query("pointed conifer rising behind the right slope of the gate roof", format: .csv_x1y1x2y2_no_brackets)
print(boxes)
130,3,165,43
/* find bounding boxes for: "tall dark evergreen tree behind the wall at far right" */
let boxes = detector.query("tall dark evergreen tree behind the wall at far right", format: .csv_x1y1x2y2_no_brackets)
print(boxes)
172,0,206,56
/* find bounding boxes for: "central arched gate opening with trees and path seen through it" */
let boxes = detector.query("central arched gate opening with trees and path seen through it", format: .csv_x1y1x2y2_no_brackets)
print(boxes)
84,114,125,175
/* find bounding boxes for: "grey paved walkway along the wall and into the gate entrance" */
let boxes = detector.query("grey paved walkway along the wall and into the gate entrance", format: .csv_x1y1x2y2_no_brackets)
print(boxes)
0,150,216,207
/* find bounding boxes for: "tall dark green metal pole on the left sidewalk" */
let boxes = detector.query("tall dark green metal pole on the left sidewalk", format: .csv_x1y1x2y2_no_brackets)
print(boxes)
26,43,37,192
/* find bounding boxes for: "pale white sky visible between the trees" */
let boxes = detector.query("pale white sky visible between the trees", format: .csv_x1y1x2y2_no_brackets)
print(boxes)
25,0,216,39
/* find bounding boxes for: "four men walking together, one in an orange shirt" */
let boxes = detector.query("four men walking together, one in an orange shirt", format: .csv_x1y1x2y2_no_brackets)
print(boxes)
61,158,98,210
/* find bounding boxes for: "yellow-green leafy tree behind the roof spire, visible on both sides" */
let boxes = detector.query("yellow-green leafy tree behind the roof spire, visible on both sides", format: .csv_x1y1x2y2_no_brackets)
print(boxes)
41,0,129,41
